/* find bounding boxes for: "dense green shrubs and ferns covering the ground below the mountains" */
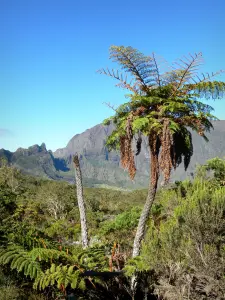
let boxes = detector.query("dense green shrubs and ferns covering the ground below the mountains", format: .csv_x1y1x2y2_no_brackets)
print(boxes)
0,158,225,300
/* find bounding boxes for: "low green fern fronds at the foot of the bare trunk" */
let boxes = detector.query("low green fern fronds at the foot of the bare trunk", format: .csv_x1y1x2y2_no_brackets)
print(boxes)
0,245,109,296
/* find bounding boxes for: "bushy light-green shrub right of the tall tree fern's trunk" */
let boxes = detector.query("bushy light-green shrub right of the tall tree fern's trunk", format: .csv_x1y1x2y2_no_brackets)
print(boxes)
125,177,225,300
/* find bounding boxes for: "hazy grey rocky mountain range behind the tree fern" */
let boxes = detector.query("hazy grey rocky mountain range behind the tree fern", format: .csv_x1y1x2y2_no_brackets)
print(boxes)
0,121,225,188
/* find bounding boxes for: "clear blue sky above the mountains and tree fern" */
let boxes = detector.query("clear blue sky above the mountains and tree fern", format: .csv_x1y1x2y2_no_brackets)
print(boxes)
0,0,225,151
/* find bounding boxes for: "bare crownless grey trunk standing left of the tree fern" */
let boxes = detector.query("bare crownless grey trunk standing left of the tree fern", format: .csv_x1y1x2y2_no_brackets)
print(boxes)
73,154,88,248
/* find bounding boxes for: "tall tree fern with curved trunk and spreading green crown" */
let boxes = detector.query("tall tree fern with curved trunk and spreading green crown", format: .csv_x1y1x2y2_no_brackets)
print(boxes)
100,46,225,264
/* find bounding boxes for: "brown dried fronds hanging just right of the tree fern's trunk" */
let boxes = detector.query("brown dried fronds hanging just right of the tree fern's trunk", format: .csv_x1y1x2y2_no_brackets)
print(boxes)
159,119,174,183
